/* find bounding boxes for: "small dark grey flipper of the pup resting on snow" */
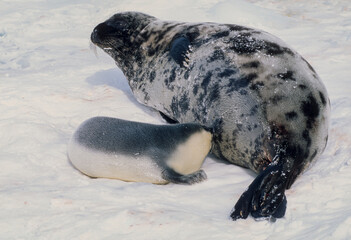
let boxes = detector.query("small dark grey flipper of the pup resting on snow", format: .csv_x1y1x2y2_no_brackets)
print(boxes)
162,168,207,185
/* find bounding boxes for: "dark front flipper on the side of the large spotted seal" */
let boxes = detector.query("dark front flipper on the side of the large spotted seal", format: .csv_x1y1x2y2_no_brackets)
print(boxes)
169,36,191,67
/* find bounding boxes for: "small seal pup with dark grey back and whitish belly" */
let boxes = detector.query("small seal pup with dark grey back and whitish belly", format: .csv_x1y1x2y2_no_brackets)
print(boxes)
68,117,212,184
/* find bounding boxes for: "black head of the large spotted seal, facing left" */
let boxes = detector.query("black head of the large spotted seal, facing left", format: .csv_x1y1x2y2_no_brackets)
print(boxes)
91,12,156,71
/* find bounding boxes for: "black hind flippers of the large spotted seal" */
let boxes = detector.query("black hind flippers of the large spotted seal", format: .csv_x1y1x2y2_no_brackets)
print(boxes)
230,163,287,220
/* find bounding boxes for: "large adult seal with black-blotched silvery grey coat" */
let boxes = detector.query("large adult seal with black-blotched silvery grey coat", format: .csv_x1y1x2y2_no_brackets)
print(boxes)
91,12,330,220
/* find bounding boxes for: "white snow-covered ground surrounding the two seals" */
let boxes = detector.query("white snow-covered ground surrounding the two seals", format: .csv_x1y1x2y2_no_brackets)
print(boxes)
0,0,351,240
